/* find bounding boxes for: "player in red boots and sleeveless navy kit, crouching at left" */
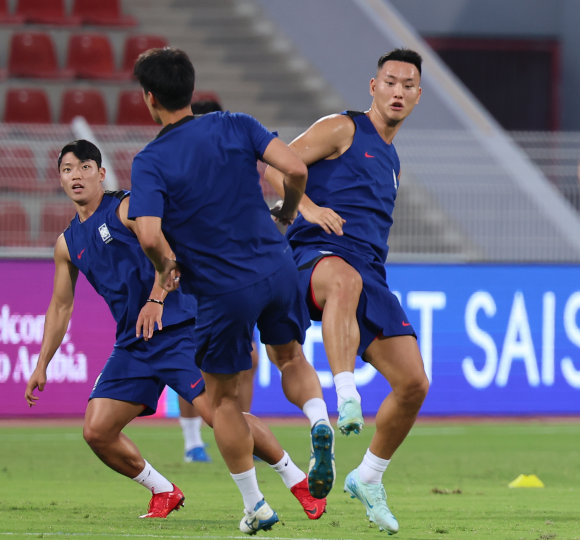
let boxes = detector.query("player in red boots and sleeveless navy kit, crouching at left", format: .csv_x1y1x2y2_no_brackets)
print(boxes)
25,140,326,519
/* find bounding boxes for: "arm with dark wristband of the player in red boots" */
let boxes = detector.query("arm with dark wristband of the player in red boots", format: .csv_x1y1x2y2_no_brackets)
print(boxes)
117,197,175,341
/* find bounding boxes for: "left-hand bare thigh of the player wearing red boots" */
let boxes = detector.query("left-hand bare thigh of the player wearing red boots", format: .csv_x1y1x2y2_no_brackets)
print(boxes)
84,398,143,436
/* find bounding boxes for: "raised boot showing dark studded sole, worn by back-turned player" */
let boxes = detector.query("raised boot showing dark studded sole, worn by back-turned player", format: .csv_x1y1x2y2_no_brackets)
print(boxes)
308,420,336,499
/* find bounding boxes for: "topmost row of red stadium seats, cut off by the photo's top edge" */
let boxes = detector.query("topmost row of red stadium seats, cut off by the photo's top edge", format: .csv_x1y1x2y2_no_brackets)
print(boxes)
0,0,137,27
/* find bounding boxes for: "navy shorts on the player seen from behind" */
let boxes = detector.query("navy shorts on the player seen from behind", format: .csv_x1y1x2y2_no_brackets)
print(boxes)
195,257,310,373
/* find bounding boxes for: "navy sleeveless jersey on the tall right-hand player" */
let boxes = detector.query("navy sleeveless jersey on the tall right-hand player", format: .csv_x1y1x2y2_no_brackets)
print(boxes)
286,111,401,263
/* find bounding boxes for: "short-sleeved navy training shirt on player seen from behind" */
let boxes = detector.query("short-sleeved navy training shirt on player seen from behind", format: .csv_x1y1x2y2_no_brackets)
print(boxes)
129,112,289,296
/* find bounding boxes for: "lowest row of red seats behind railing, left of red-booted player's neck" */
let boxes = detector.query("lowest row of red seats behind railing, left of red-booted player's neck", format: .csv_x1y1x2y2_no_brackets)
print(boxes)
0,201,75,247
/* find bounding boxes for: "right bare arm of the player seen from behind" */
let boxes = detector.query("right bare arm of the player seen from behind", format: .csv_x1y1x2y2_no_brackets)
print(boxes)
263,139,308,225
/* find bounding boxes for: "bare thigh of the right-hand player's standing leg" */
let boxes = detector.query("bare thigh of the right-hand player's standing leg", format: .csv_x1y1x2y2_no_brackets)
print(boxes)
363,336,429,398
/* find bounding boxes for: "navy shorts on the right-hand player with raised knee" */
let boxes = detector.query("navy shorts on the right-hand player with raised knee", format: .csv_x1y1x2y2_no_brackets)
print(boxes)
294,246,417,357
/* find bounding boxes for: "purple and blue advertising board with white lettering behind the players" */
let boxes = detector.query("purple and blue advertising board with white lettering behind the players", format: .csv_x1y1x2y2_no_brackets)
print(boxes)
0,260,580,417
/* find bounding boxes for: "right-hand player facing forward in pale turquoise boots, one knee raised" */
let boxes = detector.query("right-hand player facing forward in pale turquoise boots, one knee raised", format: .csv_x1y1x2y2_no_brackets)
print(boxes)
266,49,429,533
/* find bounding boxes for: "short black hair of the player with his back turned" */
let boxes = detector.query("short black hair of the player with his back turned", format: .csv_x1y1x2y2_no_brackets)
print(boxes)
133,47,195,112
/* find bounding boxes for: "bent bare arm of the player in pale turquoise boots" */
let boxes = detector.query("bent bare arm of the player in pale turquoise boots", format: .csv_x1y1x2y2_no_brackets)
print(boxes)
265,114,355,235
